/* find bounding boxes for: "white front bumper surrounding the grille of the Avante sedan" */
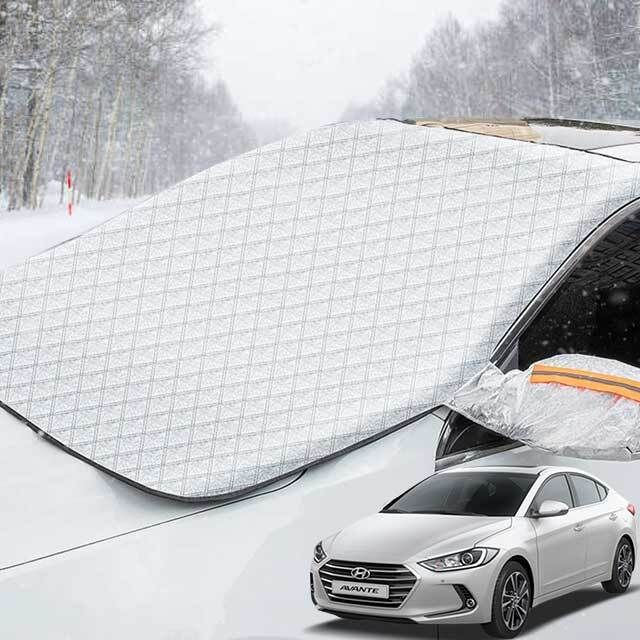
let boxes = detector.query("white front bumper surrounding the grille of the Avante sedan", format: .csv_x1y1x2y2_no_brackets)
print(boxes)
310,554,503,624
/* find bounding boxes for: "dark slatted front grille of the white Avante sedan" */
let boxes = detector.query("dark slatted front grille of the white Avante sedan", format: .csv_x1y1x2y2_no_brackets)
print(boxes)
319,560,417,609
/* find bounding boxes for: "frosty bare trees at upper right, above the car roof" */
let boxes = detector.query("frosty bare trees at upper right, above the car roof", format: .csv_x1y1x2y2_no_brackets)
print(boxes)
344,0,640,121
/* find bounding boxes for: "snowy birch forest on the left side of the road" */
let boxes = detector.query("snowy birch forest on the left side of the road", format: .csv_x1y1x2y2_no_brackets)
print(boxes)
0,0,252,209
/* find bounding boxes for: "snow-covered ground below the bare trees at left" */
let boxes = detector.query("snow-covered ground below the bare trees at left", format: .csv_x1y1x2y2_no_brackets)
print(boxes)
0,182,144,269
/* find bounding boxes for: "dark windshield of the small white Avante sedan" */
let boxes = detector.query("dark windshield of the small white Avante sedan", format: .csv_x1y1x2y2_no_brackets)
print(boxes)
383,471,536,517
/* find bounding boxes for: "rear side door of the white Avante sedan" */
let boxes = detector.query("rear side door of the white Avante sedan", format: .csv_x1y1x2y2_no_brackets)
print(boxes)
569,473,618,579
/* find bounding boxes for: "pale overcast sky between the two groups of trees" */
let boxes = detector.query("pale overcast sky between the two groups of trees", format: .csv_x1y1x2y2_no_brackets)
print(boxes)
201,0,500,128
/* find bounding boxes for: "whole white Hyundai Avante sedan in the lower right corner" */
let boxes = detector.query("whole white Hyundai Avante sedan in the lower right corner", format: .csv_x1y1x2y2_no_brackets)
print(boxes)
311,466,636,638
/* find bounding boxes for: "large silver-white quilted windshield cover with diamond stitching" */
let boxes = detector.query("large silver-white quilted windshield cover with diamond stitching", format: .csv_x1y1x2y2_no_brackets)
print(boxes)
0,121,640,499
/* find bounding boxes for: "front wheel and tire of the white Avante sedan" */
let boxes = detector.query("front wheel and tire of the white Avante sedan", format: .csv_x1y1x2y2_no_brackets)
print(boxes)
482,560,533,638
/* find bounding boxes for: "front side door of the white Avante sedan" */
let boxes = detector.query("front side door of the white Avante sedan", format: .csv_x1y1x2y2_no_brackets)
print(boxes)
531,473,587,595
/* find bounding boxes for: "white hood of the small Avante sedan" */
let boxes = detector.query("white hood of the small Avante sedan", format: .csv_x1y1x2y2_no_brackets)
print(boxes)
325,513,511,562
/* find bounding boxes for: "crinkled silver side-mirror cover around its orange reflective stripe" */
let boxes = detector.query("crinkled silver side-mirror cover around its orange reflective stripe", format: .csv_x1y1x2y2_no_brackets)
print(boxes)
447,354,640,460
